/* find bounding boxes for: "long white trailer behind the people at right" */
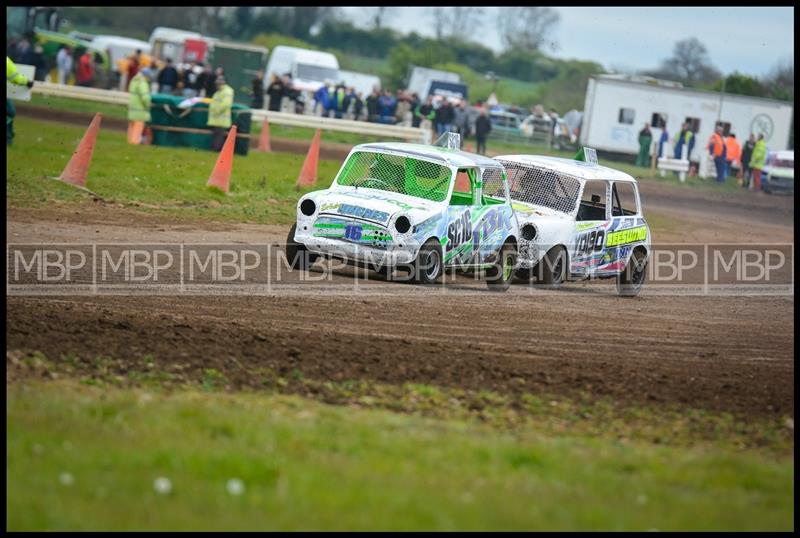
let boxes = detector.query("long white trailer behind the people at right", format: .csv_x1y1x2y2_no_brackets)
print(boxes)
580,75,794,170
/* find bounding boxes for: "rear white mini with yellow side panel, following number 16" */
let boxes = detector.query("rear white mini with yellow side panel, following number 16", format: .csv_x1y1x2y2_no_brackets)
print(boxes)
496,150,650,296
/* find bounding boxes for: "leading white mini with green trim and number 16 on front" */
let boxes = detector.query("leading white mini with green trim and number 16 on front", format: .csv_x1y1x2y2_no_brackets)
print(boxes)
287,138,519,291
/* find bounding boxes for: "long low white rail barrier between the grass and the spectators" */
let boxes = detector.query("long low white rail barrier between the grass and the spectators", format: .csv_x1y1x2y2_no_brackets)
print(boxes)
32,82,431,144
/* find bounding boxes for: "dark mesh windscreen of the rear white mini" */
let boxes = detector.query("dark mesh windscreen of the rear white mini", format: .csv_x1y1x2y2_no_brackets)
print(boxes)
501,161,581,213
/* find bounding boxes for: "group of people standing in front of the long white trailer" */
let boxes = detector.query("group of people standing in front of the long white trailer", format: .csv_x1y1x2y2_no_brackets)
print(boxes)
636,122,767,191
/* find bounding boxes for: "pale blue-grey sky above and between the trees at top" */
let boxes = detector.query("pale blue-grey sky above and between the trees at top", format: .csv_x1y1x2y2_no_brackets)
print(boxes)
342,7,794,76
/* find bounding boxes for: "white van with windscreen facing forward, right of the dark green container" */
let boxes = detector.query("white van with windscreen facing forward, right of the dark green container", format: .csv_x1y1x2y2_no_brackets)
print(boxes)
266,45,340,92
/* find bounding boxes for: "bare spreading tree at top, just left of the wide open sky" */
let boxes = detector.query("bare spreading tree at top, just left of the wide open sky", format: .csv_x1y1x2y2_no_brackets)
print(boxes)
497,7,561,50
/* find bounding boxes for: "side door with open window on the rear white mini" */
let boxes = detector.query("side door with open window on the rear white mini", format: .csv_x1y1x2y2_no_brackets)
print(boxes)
569,180,611,277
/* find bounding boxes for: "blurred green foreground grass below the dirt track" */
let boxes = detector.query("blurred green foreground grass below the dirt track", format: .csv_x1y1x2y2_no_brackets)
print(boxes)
6,381,794,530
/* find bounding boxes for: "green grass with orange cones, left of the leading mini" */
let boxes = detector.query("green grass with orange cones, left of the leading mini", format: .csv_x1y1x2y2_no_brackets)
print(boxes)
6,118,340,223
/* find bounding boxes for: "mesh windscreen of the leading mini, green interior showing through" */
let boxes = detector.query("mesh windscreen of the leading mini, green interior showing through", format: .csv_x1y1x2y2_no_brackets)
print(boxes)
336,151,453,202
